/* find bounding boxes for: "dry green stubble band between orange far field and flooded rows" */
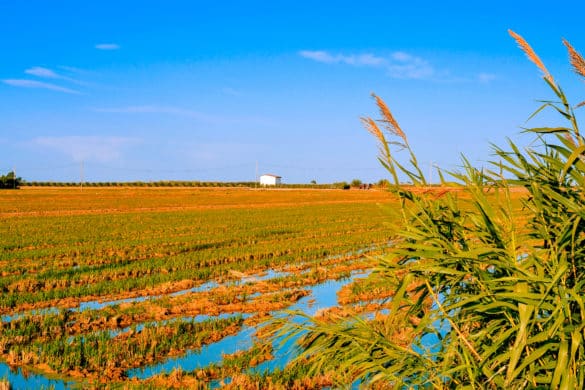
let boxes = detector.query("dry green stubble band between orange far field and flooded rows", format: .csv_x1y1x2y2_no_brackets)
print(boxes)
0,198,388,312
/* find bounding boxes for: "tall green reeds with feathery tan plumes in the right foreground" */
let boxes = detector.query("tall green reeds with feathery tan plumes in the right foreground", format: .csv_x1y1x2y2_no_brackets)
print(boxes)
274,32,585,389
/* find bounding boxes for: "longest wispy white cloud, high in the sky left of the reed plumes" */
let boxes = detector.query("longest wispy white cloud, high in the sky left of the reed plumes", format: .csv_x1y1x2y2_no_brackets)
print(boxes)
299,50,436,79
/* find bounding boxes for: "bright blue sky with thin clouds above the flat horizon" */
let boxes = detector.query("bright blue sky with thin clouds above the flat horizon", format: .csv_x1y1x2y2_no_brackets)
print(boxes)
0,0,585,183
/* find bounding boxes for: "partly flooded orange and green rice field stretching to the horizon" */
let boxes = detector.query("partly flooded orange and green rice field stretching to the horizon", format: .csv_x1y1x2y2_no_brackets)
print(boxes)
0,187,393,387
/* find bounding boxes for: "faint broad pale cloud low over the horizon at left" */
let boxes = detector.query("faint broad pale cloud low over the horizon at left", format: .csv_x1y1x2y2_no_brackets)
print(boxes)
32,136,140,163
